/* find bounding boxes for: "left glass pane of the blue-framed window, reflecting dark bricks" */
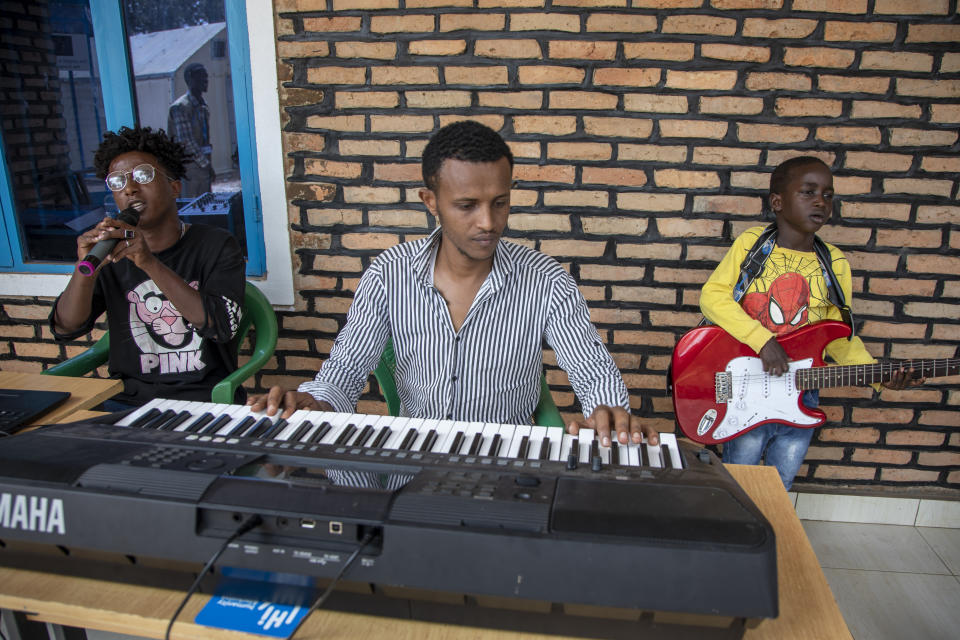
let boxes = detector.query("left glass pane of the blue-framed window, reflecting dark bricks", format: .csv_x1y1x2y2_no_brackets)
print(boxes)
0,0,107,262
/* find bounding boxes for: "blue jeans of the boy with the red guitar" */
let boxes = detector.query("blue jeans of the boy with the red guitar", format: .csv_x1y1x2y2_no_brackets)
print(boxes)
723,389,820,491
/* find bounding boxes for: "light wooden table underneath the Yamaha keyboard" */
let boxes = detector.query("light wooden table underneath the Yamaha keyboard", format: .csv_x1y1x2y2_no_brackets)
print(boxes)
0,465,851,640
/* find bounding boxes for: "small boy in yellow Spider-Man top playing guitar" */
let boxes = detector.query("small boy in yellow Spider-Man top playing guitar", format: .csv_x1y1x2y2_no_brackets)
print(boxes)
688,156,923,490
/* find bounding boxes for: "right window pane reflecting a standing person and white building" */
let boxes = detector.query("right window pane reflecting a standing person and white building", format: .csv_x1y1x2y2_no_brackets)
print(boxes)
121,0,247,254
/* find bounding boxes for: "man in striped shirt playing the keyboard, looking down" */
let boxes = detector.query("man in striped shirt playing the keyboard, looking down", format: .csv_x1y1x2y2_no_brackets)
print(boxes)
247,121,659,446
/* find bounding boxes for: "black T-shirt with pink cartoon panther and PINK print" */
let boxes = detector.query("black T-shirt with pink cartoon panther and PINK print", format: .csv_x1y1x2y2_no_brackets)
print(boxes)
50,224,245,404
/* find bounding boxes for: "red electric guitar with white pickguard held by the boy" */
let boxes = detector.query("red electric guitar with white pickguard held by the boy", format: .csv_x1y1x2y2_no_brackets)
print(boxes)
671,320,960,444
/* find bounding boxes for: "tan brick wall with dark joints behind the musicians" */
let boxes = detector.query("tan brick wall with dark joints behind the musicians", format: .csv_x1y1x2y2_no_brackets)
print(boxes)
0,0,960,496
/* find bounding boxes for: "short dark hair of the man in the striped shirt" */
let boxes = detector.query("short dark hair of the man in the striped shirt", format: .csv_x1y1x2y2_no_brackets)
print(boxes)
422,120,513,189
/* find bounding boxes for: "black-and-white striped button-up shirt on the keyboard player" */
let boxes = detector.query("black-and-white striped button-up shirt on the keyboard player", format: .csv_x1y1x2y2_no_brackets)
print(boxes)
299,228,628,424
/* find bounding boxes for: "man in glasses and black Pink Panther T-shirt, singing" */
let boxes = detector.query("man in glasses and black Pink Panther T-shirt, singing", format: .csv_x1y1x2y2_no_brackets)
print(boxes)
50,127,244,411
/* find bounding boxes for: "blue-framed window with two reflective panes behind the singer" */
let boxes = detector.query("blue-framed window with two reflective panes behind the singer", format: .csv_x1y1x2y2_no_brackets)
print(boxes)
0,0,264,275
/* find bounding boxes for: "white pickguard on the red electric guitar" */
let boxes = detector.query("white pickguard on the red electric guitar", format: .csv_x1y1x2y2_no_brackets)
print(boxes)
711,356,822,440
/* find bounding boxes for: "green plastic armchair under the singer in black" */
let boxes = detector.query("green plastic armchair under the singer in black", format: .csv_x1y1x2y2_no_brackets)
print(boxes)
43,282,277,404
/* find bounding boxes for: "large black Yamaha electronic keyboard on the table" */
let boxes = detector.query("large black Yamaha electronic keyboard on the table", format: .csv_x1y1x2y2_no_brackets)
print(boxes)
0,400,778,630
